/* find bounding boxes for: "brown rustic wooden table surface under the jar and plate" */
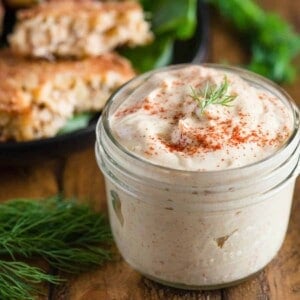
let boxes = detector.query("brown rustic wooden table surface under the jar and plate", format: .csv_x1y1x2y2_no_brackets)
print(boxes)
0,0,300,300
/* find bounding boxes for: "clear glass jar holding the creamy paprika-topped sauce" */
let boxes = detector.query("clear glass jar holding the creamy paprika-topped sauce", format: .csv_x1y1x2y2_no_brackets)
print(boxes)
96,64,300,289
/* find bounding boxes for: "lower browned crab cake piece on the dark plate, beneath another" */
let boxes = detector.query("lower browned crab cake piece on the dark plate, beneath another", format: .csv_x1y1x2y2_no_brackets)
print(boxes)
0,50,135,141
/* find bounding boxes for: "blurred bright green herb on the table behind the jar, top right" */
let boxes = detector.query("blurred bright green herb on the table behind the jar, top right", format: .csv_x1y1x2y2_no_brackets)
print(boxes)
207,0,300,82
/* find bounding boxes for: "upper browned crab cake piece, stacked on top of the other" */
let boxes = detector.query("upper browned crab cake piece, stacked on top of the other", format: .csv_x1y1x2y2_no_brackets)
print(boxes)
9,0,152,57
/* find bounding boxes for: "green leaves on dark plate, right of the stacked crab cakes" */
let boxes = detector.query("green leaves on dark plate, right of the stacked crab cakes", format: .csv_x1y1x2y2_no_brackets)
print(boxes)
120,0,197,73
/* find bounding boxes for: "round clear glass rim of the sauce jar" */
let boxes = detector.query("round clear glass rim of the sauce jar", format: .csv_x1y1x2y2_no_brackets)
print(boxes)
96,63,300,176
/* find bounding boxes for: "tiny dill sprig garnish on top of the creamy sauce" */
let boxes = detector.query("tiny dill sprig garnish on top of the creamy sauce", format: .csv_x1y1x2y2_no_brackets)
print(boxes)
190,76,236,115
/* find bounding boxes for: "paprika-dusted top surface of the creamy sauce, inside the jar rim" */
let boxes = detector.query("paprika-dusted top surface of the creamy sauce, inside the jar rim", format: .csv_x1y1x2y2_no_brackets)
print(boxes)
110,66,292,171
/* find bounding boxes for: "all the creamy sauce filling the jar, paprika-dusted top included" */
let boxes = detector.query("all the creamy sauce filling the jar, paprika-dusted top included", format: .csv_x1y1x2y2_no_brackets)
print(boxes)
97,66,299,288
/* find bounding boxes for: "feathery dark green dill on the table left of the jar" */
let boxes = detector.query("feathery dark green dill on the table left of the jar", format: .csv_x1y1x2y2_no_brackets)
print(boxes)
0,196,112,299
